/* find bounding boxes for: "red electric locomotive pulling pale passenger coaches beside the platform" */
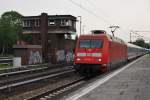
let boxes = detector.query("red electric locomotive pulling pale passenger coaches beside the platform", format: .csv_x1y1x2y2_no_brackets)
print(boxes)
74,30,149,76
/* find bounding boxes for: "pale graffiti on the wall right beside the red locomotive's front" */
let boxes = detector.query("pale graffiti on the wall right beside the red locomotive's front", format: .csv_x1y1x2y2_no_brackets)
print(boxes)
56,50,74,62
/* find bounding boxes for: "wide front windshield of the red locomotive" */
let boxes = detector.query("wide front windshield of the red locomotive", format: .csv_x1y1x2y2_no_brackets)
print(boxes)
79,40,103,48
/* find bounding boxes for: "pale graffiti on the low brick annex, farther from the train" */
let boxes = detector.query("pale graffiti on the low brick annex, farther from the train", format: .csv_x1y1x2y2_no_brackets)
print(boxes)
29,51,42,64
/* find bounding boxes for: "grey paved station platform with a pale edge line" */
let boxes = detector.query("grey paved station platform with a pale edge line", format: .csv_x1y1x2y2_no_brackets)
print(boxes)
63,54,150,100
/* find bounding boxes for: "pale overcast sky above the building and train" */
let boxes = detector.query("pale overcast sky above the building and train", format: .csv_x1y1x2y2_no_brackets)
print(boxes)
0,0,150,41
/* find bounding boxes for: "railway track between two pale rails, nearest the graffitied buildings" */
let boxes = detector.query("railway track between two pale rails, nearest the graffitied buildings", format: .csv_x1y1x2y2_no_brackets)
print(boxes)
0,67,72,91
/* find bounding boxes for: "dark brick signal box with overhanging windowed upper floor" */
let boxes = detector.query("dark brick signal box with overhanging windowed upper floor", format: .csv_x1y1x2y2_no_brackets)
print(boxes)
22,13,76,63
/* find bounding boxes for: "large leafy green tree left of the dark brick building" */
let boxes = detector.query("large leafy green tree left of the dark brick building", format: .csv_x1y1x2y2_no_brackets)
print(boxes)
0,11,22,54
